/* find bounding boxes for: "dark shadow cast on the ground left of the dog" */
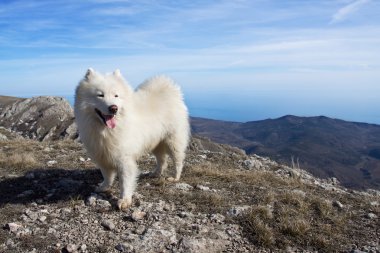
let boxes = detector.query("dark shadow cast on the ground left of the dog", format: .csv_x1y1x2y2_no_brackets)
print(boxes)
0,168,102,207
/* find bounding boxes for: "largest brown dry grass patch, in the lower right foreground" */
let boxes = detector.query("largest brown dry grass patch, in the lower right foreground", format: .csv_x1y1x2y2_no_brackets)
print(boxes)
239,188,349,252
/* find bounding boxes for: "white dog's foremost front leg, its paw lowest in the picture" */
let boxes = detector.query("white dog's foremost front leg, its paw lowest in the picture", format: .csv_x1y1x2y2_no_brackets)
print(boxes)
117,157,138,211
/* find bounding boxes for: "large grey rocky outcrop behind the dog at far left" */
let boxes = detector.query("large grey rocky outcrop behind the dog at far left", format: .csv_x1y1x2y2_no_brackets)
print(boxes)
0,96,78,141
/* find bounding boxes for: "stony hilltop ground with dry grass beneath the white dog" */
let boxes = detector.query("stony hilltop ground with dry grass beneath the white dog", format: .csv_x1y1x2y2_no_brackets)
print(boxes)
0,128,380,253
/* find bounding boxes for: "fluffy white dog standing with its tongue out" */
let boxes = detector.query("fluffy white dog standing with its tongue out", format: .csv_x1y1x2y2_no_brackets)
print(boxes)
74,69,190,210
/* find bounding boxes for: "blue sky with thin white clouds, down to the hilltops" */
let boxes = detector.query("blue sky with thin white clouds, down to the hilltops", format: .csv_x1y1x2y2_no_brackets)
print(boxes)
0,0,380,124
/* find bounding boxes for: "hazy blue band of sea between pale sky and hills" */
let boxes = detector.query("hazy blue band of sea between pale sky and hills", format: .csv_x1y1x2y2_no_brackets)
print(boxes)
57,95,380,125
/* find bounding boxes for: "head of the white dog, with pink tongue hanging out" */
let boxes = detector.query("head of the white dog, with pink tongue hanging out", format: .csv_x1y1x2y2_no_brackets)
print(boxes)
75,68,131,129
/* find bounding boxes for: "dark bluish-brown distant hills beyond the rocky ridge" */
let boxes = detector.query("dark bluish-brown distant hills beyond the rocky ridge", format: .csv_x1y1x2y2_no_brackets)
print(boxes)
191,115,380,189
